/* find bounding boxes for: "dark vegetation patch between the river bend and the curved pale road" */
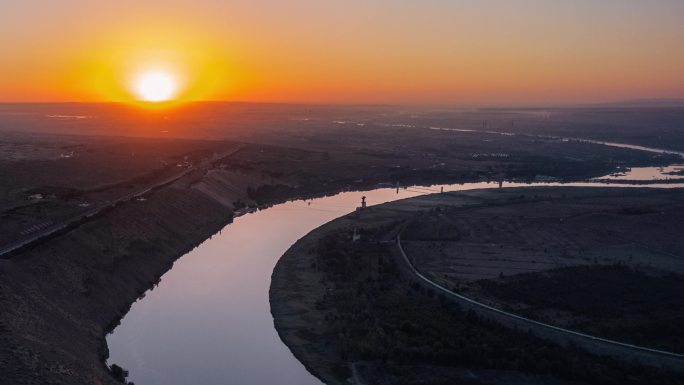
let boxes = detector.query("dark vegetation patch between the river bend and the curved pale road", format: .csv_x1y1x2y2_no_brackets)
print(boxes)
315,234,683,384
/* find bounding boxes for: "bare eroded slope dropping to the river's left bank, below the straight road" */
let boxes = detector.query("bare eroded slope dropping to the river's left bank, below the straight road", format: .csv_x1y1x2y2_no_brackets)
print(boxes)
0,172,250,385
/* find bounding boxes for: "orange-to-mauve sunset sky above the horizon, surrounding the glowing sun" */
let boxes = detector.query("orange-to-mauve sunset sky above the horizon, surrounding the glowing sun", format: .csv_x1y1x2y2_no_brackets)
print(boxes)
0,0,684,105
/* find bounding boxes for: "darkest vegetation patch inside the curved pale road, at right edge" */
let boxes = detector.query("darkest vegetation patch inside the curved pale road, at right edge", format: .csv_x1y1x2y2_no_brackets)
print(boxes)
478,265,684,352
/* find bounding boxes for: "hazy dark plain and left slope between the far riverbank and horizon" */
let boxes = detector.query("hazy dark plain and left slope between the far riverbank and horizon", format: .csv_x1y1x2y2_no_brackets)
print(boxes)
0,103,684,384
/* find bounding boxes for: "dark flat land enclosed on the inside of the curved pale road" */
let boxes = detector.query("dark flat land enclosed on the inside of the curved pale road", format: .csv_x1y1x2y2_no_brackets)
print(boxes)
403,192,684,352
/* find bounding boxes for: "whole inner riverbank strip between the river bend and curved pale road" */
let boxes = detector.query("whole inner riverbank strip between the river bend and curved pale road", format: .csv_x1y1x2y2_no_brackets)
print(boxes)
270,188,678,384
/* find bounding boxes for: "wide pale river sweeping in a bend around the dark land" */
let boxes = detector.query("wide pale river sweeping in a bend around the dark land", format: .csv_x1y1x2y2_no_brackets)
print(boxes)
107,176,684,385
